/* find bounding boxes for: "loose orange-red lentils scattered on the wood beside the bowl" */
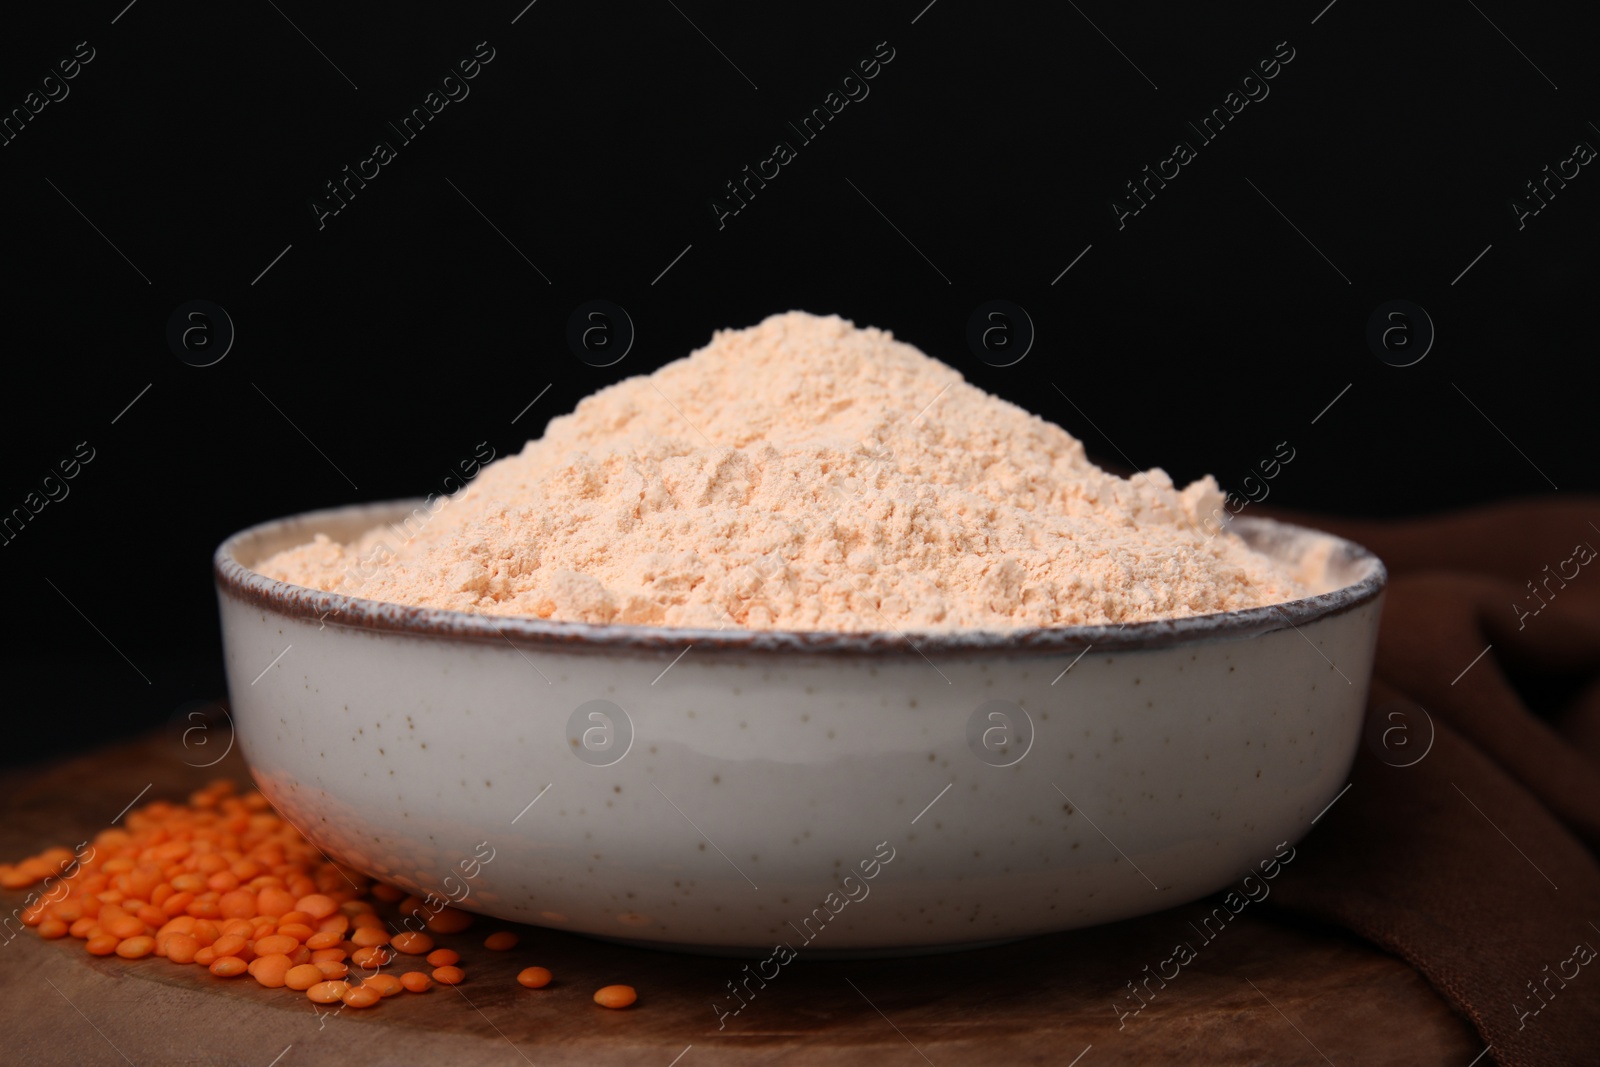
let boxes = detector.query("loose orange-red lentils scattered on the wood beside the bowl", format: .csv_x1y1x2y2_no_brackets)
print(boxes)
0,781,638,1008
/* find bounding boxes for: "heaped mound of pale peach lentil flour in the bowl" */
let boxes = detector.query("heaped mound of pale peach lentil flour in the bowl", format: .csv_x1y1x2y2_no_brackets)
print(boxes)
259,312,1309,630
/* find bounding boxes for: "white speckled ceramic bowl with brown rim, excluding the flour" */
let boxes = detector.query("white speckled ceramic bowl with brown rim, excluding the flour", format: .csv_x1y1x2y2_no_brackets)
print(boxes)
216,502,1386,957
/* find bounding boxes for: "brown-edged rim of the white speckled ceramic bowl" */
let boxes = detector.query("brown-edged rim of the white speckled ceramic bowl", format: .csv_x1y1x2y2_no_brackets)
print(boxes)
213,499,1387,659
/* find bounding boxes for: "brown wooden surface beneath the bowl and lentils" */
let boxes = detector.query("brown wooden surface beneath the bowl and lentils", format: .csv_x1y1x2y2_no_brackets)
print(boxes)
0,737,1483,1067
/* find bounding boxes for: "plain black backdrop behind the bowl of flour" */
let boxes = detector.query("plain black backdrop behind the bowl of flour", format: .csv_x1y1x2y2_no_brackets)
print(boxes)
0,0,1600,761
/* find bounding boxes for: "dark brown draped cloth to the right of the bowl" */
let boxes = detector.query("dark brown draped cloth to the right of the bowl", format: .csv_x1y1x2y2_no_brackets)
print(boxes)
1274,496,1600,1067
